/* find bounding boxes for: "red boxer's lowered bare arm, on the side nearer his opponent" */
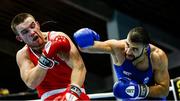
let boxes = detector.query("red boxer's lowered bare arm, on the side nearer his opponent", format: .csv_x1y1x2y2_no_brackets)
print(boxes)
54,32,86,87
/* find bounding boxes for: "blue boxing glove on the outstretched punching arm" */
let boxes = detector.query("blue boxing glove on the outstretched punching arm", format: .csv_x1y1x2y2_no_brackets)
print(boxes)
74,28,100,48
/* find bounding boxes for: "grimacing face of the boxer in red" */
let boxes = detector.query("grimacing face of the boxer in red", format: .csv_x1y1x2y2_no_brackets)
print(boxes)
16,17,44,48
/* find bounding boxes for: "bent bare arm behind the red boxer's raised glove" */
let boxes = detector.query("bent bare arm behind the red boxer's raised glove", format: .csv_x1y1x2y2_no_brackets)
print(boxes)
16,48,47,89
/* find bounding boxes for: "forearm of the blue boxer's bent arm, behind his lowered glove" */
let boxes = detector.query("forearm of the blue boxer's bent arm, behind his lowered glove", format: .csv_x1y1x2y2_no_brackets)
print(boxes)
148,85,169,97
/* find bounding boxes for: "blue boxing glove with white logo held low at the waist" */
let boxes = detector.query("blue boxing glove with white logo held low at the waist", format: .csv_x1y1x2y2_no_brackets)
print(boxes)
113,78,149,99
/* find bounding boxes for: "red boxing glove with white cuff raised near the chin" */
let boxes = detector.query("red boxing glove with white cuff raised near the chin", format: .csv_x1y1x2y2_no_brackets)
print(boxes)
39,36,70,69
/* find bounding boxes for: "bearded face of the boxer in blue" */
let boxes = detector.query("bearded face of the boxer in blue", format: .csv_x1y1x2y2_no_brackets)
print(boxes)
125,38,145,60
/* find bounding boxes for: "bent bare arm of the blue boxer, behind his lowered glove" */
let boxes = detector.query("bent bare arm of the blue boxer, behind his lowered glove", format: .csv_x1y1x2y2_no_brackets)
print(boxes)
148,50,170,97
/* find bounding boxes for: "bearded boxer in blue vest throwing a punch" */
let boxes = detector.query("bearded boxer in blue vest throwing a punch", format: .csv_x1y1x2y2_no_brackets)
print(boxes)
74,27,170,100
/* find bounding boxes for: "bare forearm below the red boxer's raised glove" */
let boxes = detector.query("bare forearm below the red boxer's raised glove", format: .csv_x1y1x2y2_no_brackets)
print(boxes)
23,65,47,89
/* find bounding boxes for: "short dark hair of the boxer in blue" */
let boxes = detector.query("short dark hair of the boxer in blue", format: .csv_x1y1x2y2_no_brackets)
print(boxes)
128,27,150,45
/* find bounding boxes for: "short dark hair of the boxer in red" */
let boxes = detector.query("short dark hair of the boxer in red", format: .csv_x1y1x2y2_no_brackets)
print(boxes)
11,13,34,35
